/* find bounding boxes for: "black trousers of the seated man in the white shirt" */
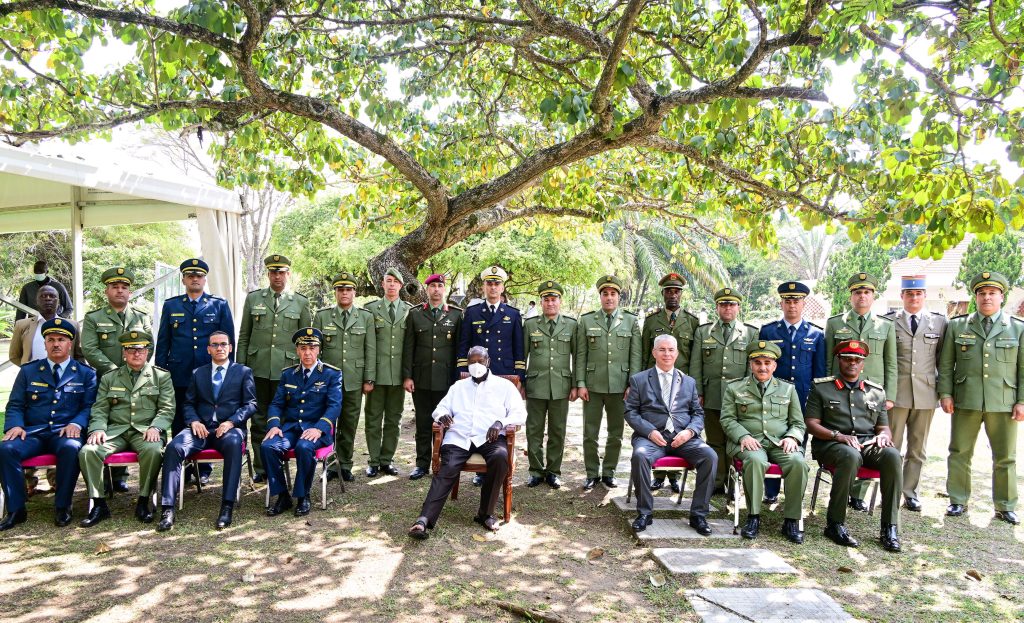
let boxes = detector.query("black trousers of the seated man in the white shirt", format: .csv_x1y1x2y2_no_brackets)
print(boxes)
420,434,509,526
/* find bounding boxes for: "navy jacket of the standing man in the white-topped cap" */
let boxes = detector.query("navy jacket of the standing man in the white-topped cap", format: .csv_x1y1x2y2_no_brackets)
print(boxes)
456,301,526,382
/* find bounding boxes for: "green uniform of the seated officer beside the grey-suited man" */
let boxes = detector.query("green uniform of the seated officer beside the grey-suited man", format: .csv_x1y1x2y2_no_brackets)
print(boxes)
722,376,808,520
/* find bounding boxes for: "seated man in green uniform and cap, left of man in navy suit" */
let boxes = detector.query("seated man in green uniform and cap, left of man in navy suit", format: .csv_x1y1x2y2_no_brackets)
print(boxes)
78,331,174,528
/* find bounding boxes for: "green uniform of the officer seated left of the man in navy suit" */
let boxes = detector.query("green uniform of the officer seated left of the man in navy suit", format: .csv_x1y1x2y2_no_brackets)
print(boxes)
78,364,174,498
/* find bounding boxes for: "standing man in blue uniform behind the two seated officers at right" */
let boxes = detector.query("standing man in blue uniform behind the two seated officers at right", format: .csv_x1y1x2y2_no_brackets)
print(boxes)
758,281,828,504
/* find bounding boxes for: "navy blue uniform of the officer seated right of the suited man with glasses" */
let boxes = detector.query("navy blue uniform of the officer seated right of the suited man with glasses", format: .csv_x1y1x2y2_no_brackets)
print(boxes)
261,362,341,498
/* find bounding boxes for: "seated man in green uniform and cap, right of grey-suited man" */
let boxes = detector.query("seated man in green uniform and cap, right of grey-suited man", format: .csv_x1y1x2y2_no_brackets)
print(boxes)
722,340,808,544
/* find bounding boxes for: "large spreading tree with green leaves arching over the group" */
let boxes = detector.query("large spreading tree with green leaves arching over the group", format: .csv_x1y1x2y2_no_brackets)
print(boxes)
0,0,1024,291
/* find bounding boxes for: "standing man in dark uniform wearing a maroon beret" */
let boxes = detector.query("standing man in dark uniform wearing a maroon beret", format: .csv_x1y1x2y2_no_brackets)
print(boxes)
401,274,462,481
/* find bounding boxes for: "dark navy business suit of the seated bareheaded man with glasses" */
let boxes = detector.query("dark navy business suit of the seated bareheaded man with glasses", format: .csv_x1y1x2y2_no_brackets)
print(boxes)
160,364,256,506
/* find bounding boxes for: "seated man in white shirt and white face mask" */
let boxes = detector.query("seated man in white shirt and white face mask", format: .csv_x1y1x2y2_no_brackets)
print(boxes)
409,346,526,539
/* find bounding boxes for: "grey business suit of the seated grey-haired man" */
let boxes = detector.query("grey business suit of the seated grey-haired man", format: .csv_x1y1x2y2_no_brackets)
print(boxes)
625,367,718,517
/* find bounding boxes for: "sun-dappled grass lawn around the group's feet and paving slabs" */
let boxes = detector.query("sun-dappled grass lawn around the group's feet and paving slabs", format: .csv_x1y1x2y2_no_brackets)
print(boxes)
0,404,1024,623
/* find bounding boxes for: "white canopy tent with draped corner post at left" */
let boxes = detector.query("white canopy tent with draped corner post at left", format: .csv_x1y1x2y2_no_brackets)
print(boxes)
0,144,245,320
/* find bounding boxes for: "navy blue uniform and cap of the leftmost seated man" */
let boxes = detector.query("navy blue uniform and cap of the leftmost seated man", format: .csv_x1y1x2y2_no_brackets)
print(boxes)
0,318,96,530
